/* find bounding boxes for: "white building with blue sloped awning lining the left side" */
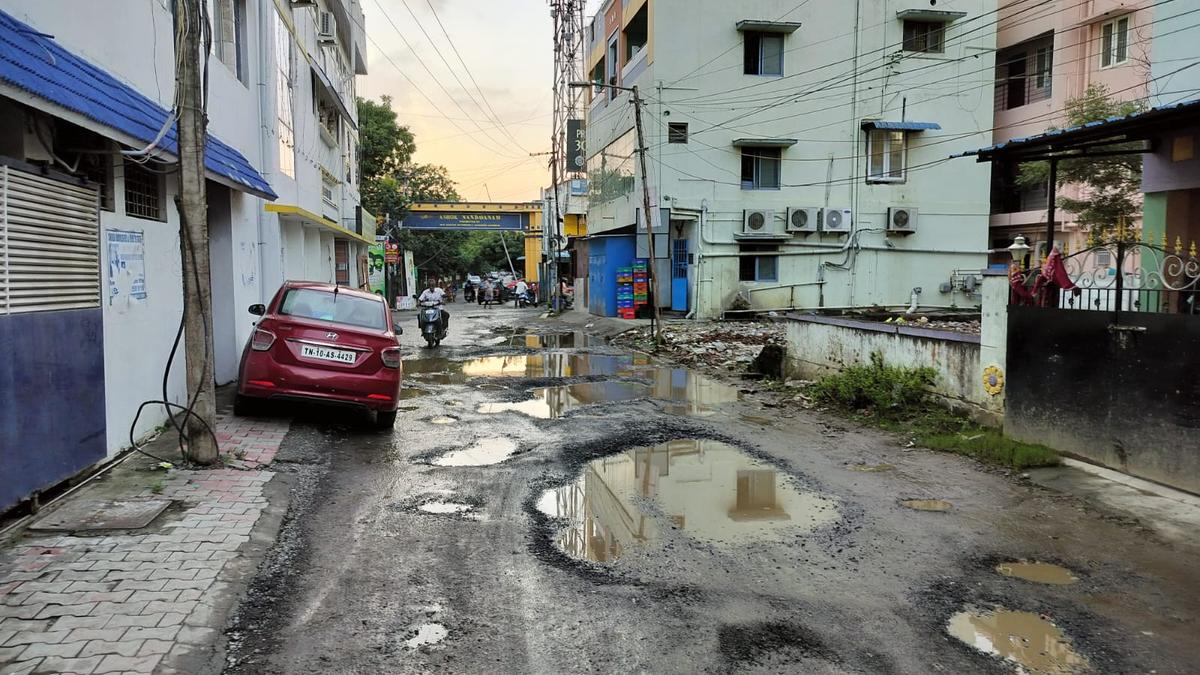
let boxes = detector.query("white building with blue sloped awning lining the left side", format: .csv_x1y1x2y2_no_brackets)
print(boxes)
0,0,374,507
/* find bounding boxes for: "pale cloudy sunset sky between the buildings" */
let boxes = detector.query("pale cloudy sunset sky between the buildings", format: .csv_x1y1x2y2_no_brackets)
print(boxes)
359,0,599,202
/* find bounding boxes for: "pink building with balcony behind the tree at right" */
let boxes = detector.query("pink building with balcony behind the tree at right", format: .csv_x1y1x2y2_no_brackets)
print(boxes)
990,0,1153,262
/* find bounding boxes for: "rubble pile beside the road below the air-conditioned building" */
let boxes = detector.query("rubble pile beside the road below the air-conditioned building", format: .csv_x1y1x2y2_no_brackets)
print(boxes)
613,322,786,368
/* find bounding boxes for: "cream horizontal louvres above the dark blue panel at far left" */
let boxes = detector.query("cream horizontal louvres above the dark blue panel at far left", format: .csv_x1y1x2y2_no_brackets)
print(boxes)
0,166,101,315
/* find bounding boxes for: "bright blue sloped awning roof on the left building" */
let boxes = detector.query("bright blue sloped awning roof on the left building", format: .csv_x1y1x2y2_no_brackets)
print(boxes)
0,12,276,199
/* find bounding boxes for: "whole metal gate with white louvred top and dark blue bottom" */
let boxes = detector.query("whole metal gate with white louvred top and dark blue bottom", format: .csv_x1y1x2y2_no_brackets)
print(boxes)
0,166,107,509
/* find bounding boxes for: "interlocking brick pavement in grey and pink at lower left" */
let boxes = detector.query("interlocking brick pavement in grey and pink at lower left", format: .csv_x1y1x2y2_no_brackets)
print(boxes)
0,416,288,675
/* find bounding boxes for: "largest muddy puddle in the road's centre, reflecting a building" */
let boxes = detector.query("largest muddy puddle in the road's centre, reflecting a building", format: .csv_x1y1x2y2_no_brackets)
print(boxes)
538,438,839,562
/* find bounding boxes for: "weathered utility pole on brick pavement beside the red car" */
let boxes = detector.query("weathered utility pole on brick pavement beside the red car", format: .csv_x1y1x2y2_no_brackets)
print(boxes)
175,0,217,464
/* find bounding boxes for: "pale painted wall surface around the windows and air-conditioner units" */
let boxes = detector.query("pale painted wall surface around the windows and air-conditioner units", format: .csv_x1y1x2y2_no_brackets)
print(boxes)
588,0,995,317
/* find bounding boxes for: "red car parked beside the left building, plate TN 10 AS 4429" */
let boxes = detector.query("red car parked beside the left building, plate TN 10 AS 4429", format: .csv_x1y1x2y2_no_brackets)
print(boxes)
234,281,403,429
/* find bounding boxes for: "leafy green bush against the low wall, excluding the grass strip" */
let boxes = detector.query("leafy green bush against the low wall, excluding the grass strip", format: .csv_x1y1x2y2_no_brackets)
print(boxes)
812,353,937,416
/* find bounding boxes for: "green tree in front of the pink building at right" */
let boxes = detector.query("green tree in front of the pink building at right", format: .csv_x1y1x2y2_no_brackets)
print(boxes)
1016,84,1144,239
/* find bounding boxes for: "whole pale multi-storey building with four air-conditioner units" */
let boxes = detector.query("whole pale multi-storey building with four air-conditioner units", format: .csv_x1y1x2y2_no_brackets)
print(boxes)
586,0,996,317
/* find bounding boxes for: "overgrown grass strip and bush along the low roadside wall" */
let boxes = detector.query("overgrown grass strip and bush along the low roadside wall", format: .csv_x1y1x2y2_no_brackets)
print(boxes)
809,354,1058,470
